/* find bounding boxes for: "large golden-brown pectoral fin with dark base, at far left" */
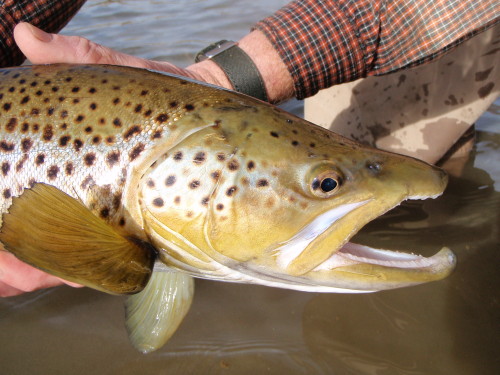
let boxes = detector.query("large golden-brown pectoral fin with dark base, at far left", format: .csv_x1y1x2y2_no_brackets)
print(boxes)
0,184,154,294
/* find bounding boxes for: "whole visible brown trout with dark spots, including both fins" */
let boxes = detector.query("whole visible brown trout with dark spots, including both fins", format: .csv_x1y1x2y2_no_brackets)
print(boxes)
0,65,455,351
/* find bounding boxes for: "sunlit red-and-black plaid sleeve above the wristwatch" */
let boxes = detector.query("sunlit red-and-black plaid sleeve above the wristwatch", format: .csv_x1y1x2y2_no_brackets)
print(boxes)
255,0,500,99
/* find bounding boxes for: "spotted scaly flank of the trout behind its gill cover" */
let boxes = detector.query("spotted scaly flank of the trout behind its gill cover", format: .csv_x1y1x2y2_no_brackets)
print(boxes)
0,67,223,229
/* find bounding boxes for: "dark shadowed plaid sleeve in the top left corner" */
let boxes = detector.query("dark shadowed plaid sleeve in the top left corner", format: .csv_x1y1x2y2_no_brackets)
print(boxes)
0,0,85,67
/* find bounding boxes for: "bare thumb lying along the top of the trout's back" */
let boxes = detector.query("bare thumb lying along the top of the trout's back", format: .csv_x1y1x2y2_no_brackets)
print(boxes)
14,22,150,68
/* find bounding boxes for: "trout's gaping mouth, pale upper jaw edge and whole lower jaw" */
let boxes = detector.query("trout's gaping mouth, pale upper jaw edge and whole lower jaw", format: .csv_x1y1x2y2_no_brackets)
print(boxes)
274,194,456,293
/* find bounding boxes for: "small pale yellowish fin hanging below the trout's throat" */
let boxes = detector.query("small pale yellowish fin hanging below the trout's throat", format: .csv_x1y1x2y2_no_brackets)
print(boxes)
125,272,194,353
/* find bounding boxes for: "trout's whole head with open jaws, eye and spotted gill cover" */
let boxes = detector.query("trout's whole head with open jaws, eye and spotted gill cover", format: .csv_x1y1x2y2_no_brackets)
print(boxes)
139,99,454,291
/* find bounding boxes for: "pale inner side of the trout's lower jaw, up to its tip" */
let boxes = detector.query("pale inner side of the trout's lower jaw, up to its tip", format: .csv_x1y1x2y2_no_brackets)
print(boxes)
313,242,456,272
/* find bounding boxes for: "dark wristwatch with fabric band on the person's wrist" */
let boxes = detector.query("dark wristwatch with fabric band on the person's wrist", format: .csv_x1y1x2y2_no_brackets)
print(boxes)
195,40,268,102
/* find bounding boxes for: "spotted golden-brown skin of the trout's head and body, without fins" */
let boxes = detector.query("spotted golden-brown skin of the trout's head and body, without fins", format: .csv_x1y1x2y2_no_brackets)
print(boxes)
0,65,454,291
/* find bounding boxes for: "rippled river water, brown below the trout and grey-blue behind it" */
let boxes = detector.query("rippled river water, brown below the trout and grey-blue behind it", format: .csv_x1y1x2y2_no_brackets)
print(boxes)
0,0,500,375
